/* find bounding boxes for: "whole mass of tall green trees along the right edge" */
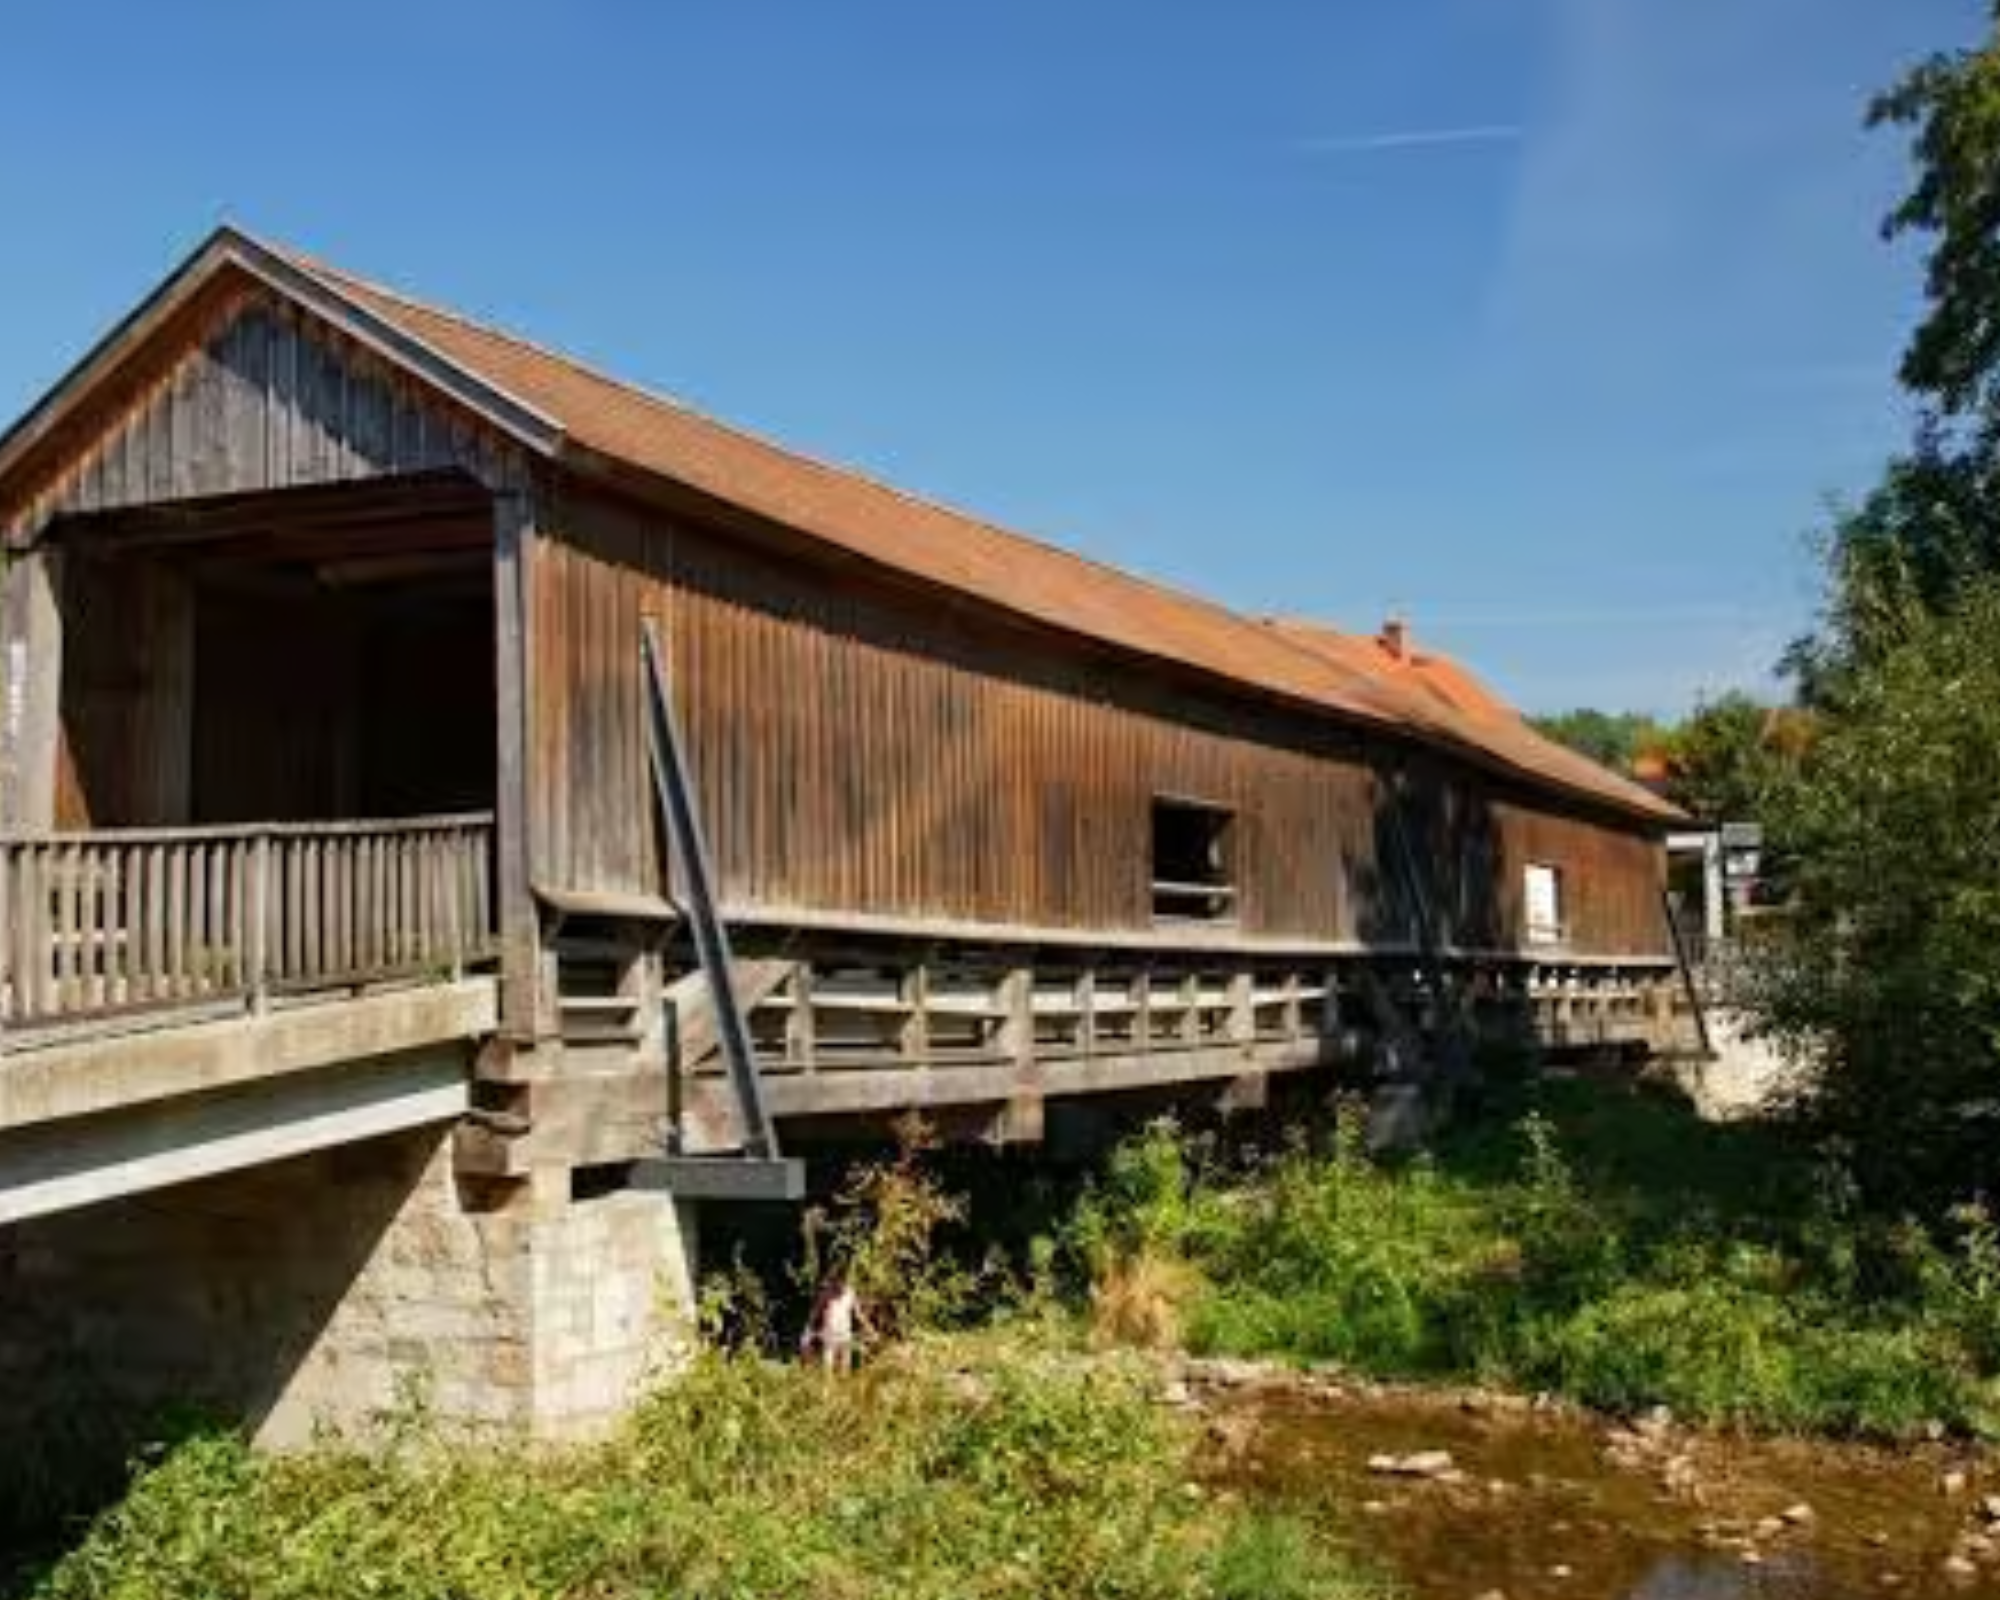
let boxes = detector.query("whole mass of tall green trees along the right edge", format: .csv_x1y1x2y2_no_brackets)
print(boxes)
1752,12,2000,1214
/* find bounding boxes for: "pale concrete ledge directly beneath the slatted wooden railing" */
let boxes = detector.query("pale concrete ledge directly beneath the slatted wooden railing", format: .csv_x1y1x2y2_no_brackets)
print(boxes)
0,978,500,1132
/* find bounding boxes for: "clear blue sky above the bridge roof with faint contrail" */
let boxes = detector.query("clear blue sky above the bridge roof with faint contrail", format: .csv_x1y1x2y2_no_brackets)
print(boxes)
0,0,1984,712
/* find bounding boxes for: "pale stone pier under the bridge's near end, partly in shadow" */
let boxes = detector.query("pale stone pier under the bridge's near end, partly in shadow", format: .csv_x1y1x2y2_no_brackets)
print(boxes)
0,1126,694,1448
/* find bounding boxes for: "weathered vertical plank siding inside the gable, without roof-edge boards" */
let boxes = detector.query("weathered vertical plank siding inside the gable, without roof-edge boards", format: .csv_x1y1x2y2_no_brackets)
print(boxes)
0,280,528,540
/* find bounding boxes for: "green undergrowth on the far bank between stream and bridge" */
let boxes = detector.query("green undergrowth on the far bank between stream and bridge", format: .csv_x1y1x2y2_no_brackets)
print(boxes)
1074,1082,2000,1436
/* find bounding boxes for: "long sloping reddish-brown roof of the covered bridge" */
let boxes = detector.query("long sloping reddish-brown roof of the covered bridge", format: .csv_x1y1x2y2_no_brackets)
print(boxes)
264,246,1678,822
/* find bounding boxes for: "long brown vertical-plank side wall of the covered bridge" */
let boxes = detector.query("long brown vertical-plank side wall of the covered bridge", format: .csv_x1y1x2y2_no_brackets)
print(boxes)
530,484,1664,956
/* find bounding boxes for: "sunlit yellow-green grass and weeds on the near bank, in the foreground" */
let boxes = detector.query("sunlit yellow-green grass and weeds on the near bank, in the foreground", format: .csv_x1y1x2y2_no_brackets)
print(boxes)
27,1344,1364,1600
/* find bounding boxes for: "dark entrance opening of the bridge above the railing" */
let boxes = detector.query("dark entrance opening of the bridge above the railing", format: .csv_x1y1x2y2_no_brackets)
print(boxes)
52,474,496,830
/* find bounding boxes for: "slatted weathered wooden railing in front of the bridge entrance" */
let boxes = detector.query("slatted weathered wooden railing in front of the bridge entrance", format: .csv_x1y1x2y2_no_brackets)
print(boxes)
0,812,494,1038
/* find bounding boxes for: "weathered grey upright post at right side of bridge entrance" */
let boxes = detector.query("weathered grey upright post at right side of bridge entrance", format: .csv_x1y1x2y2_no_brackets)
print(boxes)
494,490,554,1044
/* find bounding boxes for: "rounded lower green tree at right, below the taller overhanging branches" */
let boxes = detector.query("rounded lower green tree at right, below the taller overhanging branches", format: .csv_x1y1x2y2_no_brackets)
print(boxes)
1760,582,2000,1200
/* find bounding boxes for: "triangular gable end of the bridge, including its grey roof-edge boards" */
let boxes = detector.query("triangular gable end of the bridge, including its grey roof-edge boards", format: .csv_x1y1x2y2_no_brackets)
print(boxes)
0,228,562,546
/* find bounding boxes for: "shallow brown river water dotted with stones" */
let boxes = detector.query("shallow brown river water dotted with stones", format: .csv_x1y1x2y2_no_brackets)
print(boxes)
1194,1382,2000,1600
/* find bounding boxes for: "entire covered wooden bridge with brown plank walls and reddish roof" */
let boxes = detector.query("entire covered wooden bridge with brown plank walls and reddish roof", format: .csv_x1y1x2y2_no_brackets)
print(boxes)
0,230,1674,1448
